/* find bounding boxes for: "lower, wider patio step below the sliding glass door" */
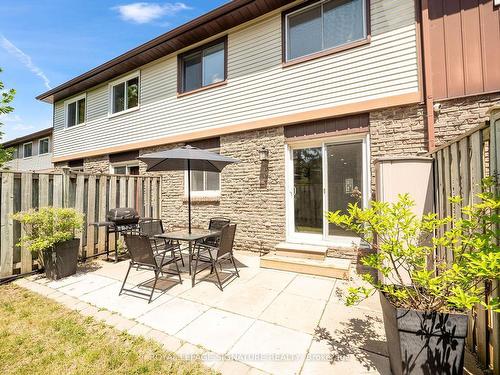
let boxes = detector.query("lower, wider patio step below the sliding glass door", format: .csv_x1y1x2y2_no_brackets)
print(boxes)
260,254,351,280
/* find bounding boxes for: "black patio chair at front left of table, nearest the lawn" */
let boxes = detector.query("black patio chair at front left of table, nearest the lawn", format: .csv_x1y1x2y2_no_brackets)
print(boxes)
119,234,182,303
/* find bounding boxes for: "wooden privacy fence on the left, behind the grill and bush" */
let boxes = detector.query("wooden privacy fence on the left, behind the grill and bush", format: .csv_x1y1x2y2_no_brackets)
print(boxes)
0,171,161,277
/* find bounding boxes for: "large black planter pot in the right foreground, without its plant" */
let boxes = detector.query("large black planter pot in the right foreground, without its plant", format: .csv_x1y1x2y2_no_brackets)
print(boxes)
380,293,468,375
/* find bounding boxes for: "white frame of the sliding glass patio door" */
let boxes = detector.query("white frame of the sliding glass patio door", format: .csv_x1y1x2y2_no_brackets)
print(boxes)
285,134,371,247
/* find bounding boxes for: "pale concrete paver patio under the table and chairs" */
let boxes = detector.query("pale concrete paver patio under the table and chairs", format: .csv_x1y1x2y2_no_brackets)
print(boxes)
18,253,390,374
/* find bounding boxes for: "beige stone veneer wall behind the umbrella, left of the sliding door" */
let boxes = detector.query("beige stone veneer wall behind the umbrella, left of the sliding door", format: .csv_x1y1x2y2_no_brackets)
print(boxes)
140,127,285,252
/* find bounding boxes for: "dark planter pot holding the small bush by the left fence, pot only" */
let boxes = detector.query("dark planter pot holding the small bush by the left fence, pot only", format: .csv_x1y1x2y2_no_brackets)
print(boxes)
43,238,80,280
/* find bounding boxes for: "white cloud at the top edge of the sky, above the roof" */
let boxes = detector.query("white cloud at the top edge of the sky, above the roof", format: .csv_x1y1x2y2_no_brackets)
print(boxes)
113,2,191,24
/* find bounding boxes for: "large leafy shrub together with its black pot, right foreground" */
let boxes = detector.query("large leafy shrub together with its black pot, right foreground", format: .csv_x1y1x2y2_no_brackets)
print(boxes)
327,180,500,374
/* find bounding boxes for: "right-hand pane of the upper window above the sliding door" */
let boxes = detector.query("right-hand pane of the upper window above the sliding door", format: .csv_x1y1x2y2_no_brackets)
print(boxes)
323,0,365,48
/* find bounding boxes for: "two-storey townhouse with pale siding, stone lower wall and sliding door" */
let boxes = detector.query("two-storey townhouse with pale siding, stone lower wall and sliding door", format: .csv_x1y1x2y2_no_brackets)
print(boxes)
38,0,500,251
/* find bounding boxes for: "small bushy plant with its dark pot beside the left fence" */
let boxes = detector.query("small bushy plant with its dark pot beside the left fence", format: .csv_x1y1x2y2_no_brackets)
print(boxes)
13,207,83,280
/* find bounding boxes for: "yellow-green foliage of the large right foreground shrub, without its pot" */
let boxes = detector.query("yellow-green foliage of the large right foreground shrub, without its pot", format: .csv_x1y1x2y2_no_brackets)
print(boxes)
328,180,500,312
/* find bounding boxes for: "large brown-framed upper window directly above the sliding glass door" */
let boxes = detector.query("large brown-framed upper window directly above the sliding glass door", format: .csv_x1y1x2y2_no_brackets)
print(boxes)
285,0,368,61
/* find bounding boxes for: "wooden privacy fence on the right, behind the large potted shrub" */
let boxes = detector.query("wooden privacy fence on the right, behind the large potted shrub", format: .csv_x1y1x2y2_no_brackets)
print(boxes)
431,117,500,374
